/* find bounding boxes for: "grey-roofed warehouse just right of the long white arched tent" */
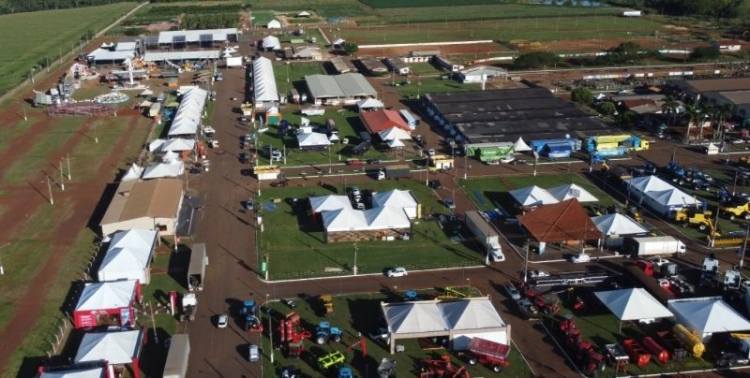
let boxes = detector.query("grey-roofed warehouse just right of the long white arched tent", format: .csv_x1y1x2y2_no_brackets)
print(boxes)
304,73,377,105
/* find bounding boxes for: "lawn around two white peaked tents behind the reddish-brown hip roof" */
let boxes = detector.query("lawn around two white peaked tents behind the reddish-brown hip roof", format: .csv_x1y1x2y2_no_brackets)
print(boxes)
460,173,615,216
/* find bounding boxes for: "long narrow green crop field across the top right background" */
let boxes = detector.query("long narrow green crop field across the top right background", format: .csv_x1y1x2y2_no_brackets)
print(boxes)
339,16,661,45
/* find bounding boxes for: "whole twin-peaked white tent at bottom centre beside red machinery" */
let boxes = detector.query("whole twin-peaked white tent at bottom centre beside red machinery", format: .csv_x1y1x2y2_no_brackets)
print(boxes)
381,297,510,353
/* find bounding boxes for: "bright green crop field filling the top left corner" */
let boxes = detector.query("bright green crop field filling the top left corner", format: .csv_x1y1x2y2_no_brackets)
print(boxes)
0,2,136,94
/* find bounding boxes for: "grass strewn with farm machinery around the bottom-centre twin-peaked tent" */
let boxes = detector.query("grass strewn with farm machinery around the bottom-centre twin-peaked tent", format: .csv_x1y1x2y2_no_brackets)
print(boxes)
262,294,533,378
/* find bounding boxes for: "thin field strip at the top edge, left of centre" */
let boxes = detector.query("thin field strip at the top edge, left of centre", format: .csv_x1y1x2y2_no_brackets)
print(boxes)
247,0,368,17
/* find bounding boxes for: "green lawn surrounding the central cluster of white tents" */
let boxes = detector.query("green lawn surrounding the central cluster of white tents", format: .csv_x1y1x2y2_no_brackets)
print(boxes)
258,177,482,279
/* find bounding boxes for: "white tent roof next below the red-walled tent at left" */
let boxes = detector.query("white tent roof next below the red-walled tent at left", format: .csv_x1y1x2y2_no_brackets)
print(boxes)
75,329,143,365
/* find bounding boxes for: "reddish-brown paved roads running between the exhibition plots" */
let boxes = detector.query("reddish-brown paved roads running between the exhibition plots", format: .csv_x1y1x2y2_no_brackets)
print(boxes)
181,31,750,377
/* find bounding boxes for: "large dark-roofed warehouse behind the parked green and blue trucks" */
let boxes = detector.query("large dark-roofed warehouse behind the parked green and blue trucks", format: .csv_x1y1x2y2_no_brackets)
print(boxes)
423,88,615,158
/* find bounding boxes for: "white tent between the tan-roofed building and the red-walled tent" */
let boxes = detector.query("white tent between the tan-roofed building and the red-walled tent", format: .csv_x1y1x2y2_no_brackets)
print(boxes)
97,229,158,284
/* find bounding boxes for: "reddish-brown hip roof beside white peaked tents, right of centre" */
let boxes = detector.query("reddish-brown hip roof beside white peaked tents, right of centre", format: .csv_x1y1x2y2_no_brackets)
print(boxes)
518,198,602,243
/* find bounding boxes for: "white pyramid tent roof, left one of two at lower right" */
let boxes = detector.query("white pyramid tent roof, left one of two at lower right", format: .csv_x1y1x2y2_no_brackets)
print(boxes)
594,288,674,320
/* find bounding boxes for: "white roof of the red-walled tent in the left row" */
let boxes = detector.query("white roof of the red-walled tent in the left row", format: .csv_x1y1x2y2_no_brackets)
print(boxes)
76,280,136,311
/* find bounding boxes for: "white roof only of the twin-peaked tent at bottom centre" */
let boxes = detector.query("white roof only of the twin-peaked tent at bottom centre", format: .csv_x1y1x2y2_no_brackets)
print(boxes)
383,298,505,334
